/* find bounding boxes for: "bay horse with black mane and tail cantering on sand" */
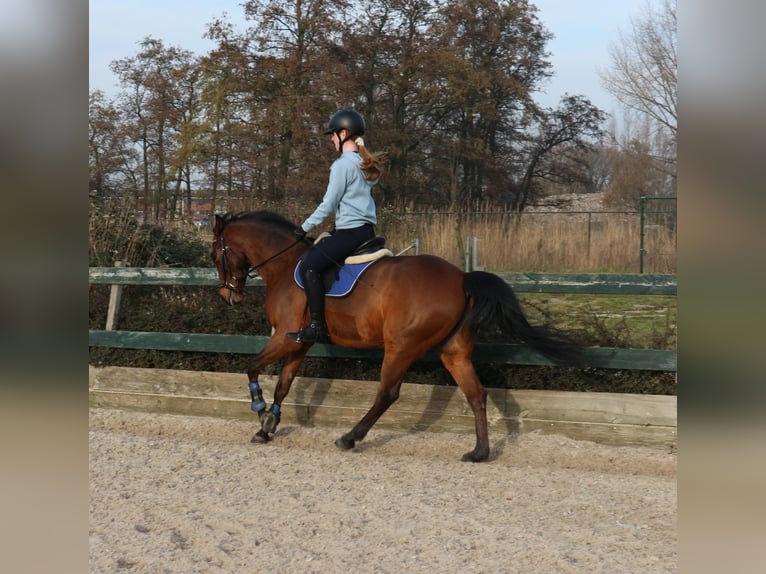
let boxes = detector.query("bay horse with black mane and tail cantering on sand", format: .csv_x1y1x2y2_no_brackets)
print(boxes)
210,211,582,462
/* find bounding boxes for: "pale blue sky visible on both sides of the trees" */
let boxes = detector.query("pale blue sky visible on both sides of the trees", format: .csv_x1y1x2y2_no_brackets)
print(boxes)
89,0,647,117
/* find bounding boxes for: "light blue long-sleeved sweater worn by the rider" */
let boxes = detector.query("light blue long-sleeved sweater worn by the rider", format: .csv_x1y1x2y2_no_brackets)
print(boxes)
301,151,378,236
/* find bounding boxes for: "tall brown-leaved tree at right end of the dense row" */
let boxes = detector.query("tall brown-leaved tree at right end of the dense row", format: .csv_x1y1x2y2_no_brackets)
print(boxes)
434,0,550,207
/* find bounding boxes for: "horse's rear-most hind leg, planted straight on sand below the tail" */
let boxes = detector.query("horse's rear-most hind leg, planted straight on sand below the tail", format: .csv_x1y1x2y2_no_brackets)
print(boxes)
440,342,489,462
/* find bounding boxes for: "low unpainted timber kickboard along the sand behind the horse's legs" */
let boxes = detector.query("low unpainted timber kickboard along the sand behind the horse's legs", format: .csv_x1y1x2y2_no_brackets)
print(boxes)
89,367,677,451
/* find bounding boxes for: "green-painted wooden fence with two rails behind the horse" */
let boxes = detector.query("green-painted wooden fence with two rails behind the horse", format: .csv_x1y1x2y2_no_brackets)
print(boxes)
88,267,677,371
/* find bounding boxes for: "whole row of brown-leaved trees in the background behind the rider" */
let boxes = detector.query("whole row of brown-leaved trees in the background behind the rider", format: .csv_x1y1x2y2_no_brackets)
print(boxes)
94,0,603,221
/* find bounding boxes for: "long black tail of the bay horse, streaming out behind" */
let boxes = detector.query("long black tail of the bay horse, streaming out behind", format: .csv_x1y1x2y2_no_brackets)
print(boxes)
463,271,584,367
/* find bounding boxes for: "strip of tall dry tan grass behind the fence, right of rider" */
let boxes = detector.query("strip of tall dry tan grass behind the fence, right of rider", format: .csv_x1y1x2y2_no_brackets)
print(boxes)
378,212,676,273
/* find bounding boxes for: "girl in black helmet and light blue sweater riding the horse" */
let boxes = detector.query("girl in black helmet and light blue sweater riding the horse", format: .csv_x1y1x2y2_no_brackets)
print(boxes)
287,110,388,343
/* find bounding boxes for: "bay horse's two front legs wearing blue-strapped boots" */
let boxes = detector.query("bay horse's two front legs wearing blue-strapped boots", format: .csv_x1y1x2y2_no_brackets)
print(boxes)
248,339,308,443
